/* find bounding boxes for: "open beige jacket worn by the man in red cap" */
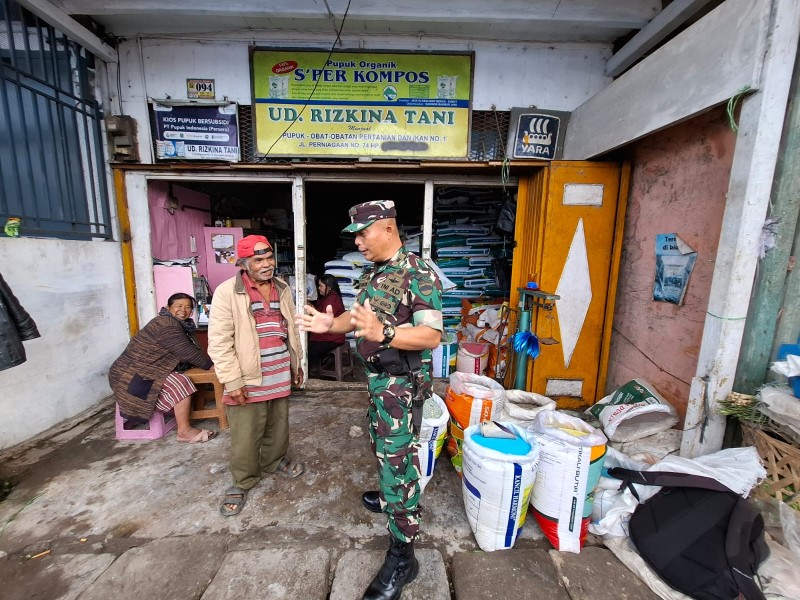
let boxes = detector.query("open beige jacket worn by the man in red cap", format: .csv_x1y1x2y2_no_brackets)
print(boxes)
208,271,300,391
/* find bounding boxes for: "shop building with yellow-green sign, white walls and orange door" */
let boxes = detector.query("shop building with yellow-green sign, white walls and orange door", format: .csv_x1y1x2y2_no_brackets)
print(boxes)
0,0,798,453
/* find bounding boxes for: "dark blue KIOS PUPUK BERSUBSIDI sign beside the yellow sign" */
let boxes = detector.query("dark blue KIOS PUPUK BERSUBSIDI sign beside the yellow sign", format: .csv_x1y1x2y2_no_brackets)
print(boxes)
152,100,241,163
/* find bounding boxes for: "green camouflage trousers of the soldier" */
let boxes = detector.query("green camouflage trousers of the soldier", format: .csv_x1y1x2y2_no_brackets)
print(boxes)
367,373,420,542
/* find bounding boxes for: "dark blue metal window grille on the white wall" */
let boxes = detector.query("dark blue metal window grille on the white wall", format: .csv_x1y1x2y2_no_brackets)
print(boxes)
0,0,111,239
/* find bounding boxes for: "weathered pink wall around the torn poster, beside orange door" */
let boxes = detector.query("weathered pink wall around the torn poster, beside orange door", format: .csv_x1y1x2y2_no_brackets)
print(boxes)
606,108,735,423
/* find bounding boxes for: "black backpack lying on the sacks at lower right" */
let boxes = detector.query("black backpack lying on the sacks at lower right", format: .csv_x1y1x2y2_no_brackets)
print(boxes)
608,467,769,600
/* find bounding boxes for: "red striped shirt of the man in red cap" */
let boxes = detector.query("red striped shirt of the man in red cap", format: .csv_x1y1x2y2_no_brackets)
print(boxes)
222,273,292,405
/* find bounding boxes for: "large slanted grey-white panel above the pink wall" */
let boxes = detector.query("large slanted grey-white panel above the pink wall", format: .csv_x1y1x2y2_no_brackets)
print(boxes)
564,0,776,160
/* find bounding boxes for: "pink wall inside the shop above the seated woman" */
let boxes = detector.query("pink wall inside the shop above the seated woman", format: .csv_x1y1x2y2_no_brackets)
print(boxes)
147,181,212,275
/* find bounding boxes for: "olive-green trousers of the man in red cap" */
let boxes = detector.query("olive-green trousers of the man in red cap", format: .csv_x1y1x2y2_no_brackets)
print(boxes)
225,396,289,490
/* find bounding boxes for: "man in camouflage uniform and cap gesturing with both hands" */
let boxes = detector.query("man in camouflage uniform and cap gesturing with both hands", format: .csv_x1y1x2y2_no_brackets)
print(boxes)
297,200,443,600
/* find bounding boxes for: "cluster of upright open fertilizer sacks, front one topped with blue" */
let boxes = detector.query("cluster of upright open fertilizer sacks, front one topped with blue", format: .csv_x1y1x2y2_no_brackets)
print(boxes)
445,372,606,552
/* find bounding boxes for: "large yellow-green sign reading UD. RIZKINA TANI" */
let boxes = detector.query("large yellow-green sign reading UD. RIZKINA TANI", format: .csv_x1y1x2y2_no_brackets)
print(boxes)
250,47,475,160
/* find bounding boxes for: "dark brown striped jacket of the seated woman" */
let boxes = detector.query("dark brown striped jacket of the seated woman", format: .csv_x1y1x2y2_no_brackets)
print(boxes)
108,316,213,419
